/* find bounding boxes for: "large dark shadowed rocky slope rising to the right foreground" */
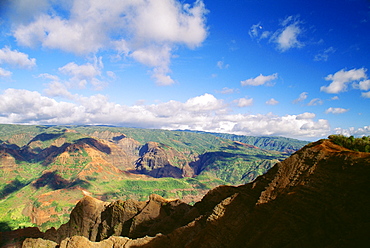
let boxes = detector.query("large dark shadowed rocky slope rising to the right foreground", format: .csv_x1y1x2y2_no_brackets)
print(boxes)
143,141,370,247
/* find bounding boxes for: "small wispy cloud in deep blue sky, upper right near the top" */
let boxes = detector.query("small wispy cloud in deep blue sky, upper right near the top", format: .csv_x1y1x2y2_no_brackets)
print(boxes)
270,16,304,52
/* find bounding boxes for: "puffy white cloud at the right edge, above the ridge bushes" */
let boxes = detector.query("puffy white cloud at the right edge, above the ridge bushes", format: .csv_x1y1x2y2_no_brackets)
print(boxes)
320,68,367,94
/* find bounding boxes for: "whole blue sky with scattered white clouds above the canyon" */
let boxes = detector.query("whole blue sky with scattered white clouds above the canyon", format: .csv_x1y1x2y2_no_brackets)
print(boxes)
0,0,370,140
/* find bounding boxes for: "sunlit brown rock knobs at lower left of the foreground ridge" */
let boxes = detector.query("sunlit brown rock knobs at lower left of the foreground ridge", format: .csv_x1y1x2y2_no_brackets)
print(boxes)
38,194,191,243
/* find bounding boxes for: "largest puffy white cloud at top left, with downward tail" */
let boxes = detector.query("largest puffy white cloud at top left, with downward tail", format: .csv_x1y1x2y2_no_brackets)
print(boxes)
13,0,208,85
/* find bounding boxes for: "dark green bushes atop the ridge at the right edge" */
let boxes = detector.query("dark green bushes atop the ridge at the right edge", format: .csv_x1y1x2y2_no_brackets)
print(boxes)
328,134,370,152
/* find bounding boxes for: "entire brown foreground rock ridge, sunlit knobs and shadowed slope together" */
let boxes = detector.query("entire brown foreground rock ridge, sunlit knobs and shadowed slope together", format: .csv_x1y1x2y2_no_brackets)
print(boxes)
23,140,370,248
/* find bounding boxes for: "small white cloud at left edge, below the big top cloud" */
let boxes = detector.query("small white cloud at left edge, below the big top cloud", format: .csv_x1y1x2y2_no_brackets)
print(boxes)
0,46,36,69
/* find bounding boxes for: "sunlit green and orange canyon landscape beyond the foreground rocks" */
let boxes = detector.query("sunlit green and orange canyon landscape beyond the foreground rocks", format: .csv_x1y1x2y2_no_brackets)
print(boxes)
0,125,307,230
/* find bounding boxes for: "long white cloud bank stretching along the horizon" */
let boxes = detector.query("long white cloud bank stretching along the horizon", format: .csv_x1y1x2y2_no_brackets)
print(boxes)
0,89,330,138
